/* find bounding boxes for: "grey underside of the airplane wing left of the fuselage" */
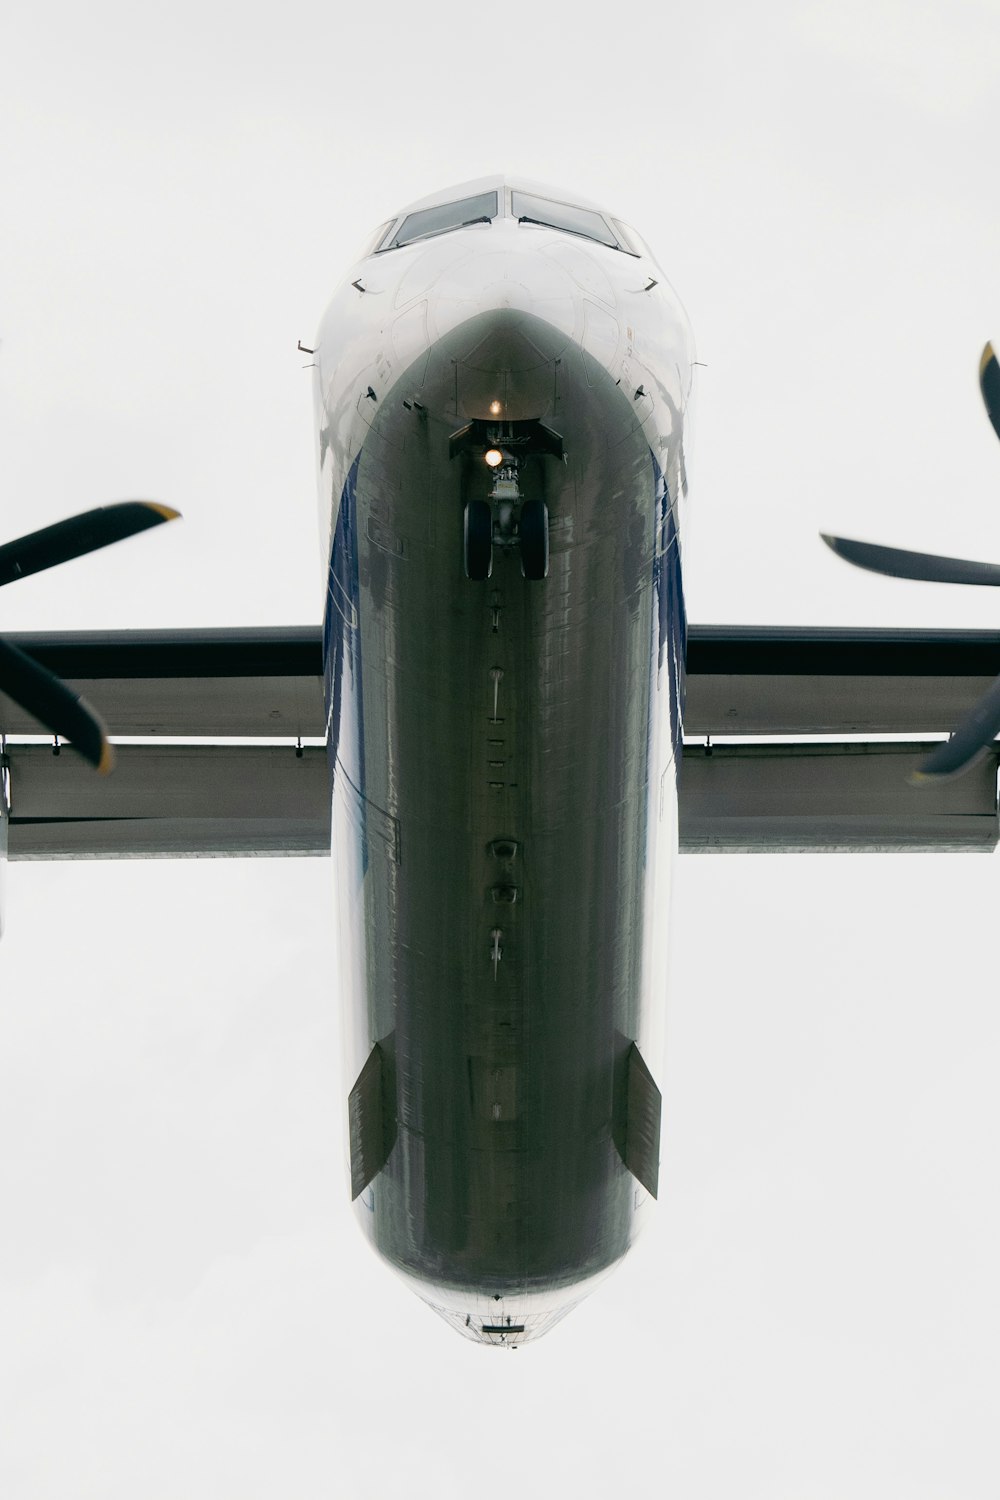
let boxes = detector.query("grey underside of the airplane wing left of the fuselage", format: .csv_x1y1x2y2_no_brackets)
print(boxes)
0,627,330,860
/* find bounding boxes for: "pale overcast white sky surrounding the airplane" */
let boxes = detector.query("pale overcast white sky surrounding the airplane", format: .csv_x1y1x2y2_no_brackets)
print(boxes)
0,0,1000,1500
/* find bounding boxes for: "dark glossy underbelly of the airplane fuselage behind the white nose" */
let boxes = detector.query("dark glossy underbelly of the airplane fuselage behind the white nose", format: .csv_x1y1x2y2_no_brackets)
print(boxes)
327,313,682,1326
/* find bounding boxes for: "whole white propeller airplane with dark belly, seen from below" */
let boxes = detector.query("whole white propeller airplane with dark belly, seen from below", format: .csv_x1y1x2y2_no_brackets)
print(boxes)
0,176,1000,1347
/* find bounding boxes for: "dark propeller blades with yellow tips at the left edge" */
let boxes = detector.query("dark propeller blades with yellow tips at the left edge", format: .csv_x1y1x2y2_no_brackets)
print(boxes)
0,500,177,771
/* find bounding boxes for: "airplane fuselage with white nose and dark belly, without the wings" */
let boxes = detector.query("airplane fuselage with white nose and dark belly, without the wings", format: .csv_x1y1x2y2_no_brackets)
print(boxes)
315,179,693,1347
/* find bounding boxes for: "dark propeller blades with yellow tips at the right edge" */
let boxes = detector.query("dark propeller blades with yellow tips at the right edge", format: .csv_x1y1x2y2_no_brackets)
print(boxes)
823,344,1000,782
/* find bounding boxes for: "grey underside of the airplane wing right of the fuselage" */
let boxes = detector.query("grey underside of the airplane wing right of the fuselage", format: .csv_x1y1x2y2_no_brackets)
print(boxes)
681,626,1000,852
